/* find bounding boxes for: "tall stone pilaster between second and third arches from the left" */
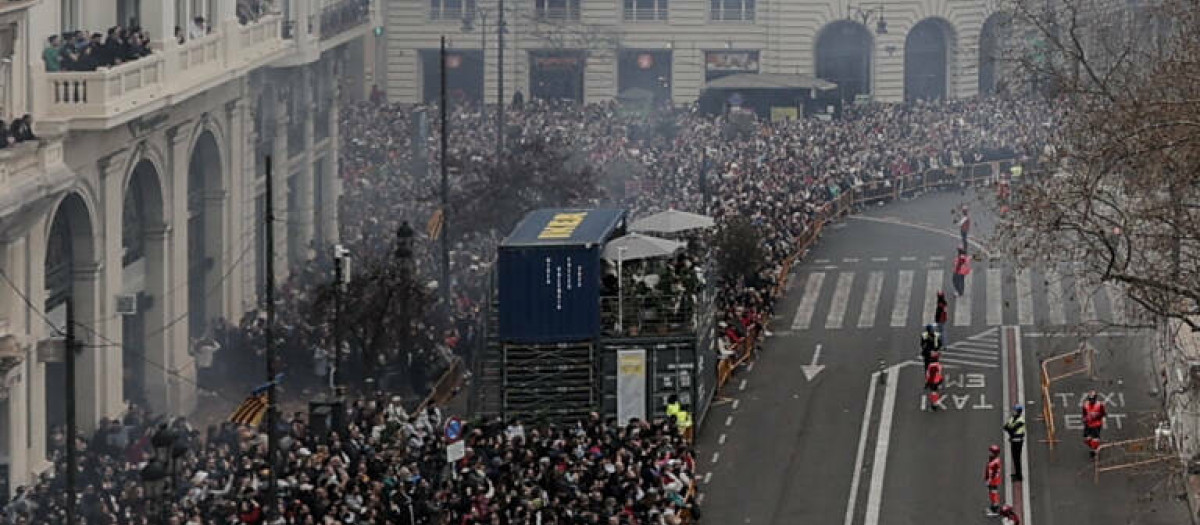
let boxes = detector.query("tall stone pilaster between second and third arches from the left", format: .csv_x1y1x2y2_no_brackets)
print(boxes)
168,122,198,414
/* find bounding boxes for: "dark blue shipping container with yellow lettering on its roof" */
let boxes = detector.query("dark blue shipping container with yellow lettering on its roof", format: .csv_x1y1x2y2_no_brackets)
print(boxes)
497,209,625,343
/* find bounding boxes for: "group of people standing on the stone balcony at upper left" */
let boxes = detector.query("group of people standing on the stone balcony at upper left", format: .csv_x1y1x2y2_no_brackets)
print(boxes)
42,25,151,72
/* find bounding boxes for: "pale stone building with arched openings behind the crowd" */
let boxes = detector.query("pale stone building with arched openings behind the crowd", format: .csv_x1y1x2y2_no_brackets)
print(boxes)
384,0,1003,103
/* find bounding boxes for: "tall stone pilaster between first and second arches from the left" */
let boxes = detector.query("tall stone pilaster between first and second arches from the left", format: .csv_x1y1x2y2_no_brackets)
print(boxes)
96,153,127,416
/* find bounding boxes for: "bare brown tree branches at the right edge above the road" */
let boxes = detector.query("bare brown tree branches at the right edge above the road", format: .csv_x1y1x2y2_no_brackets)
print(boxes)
997,0,1200,330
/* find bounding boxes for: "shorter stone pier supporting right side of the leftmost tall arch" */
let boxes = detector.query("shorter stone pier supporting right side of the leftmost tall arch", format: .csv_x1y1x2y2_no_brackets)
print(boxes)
71,261,103,433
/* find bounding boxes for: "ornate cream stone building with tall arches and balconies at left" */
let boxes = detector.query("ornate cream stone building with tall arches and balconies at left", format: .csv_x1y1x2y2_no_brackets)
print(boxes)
0,0,378,496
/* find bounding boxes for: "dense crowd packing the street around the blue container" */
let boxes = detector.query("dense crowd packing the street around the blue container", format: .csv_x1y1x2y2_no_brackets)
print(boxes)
6,92,1055,525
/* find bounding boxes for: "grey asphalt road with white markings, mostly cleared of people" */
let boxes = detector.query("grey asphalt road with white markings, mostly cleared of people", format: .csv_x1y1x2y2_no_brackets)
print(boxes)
698,192,1186,525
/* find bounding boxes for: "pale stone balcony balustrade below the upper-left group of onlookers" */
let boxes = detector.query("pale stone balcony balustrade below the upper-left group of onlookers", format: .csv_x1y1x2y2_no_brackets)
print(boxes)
35,16,284,127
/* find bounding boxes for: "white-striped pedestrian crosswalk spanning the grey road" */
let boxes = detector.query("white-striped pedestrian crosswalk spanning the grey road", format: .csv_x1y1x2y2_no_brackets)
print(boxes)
791,260,1128,330
